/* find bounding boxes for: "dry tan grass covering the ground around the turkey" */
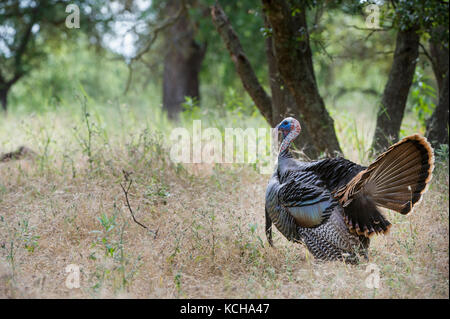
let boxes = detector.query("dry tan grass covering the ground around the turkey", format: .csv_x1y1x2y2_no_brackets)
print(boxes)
0,110,449,298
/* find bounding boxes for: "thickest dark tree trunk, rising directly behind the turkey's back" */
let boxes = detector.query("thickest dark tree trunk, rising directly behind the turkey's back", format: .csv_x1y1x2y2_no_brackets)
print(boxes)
262,0,341,155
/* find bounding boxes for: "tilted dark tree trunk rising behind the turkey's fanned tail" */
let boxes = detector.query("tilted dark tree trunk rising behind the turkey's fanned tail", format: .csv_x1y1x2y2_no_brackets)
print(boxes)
372,28,419,153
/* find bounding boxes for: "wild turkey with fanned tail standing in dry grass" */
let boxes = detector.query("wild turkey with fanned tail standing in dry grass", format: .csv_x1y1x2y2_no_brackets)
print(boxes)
265,118,434,263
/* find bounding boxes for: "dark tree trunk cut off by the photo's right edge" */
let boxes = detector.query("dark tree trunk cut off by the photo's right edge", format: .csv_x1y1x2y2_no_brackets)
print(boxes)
426,34,449,148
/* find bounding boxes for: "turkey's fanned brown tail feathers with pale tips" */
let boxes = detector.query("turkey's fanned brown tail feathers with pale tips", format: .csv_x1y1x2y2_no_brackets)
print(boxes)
336,134,434,235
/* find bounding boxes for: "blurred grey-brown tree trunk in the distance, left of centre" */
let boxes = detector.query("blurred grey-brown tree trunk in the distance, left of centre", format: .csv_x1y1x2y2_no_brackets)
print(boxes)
163,0,206,119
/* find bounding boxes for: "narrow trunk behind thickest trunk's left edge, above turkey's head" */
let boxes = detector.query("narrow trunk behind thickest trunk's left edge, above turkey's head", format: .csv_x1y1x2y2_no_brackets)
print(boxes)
264,18,320,158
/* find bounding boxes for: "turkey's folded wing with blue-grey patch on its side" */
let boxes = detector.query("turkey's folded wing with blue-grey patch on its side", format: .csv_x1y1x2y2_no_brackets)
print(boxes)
278,172,338,227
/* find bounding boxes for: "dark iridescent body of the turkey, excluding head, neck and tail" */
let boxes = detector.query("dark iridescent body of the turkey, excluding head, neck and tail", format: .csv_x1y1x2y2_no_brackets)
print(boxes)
266,158,370,262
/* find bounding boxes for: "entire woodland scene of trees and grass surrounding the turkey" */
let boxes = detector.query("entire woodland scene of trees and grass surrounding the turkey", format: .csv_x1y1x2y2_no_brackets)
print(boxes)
0,0,449,298
